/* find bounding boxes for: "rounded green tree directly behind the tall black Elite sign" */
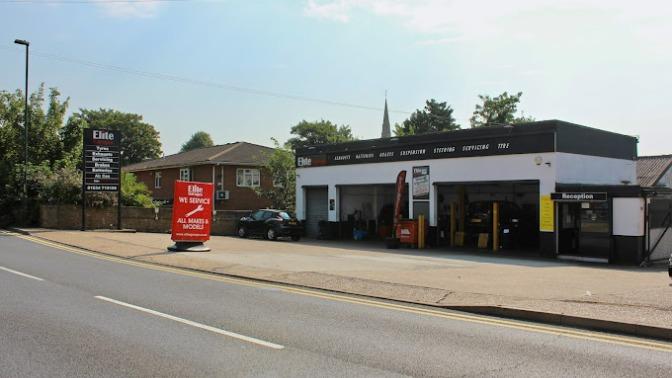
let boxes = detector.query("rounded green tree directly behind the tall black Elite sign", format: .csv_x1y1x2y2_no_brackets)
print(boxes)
62,109,161,165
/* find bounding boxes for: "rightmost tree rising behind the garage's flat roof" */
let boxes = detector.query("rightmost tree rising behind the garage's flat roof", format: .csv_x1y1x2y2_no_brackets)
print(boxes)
469,92,534,127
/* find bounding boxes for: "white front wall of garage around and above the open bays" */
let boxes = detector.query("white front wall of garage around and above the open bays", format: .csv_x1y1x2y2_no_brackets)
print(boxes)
296,153,556,226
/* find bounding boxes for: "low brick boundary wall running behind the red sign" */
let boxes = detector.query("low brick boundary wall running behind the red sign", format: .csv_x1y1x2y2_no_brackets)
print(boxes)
40,205,248,235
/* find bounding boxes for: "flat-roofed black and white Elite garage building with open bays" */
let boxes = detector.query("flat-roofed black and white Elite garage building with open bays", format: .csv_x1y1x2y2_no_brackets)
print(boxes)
296,120,646,262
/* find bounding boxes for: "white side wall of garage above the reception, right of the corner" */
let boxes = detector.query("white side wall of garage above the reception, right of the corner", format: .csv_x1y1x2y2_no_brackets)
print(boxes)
556,152,637,185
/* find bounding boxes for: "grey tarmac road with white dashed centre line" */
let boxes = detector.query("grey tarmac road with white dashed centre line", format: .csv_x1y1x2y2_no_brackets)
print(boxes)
0,233,672,377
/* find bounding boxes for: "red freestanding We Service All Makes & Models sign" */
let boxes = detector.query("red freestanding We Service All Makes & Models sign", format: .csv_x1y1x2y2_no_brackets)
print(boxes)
171,180,212,242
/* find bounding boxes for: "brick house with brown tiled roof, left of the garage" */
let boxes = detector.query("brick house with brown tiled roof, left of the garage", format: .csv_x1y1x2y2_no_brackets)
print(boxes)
123,142,273,210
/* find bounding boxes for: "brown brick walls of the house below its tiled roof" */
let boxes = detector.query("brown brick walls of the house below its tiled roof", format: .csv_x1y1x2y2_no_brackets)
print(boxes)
129,165,273,210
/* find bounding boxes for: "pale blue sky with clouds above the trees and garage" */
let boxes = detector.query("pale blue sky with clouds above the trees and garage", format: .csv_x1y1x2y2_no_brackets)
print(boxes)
0,0,672,155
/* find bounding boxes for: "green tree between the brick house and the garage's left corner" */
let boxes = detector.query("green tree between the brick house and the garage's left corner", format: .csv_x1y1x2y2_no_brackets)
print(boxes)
255,138,296,211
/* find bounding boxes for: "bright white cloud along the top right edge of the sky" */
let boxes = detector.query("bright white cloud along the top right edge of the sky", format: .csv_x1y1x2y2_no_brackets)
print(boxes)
304,0,672,45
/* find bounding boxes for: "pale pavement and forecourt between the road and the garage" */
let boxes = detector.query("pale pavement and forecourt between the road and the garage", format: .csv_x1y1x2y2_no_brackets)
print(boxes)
6,229,672,340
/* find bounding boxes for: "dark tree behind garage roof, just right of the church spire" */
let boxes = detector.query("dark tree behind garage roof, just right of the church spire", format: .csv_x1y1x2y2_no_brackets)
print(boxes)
394,99,460,136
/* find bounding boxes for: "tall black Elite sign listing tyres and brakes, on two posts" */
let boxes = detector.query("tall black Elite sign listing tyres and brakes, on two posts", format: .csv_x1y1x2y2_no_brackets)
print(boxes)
81,129,121,231
